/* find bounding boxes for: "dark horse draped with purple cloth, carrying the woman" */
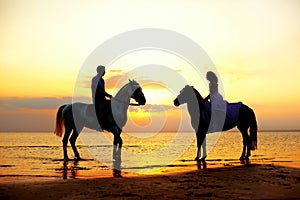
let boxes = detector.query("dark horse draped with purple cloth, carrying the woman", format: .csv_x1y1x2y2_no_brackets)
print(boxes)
173,85,257,169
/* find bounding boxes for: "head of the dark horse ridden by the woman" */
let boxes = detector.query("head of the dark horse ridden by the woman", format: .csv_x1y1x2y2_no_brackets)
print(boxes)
174,85,203,106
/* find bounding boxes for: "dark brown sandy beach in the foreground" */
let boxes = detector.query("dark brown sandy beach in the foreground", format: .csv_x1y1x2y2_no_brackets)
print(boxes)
0,164,300,199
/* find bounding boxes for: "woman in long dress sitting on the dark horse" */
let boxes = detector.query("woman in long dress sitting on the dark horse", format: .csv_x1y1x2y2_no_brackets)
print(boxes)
205,71,226,132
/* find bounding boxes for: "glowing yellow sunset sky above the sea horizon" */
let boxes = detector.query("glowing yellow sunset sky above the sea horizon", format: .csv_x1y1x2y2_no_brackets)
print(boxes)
0,0,300,132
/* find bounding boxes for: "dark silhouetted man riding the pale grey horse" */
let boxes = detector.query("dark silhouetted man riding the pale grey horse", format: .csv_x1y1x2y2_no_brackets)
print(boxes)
92,65,112,128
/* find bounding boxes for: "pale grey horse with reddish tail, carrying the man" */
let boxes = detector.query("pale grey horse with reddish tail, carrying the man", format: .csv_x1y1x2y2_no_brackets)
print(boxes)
54,80,146,161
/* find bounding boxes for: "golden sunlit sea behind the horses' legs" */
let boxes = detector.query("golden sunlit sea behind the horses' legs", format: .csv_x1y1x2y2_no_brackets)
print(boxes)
0,131,300,180
